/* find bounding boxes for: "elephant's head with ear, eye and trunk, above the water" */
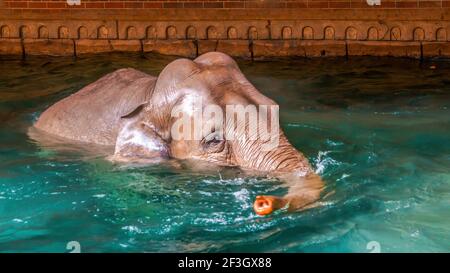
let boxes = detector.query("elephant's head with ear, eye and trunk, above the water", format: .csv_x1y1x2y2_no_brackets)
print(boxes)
115,52,324,214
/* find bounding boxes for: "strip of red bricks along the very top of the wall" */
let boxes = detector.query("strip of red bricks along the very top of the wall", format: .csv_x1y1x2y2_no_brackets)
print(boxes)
0,0,450,10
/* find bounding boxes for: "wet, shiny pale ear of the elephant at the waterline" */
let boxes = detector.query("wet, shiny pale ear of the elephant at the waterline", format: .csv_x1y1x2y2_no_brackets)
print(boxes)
112,119,169,162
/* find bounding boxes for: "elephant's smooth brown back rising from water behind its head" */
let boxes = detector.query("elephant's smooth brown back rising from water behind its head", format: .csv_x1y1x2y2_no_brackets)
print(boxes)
34,68,156,145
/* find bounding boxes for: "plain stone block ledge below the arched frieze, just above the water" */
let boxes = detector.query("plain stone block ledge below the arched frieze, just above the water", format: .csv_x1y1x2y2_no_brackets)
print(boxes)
0,38,450,58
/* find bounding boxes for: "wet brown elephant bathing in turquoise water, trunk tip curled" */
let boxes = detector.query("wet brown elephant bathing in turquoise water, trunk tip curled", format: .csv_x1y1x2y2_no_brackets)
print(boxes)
33,52,324,215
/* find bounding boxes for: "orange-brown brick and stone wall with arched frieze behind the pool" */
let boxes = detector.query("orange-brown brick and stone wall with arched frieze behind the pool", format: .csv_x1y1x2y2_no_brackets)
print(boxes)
0,0,450,58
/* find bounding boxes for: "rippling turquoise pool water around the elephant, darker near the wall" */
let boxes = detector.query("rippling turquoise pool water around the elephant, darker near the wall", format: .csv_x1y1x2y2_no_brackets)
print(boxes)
0,54,450,252
